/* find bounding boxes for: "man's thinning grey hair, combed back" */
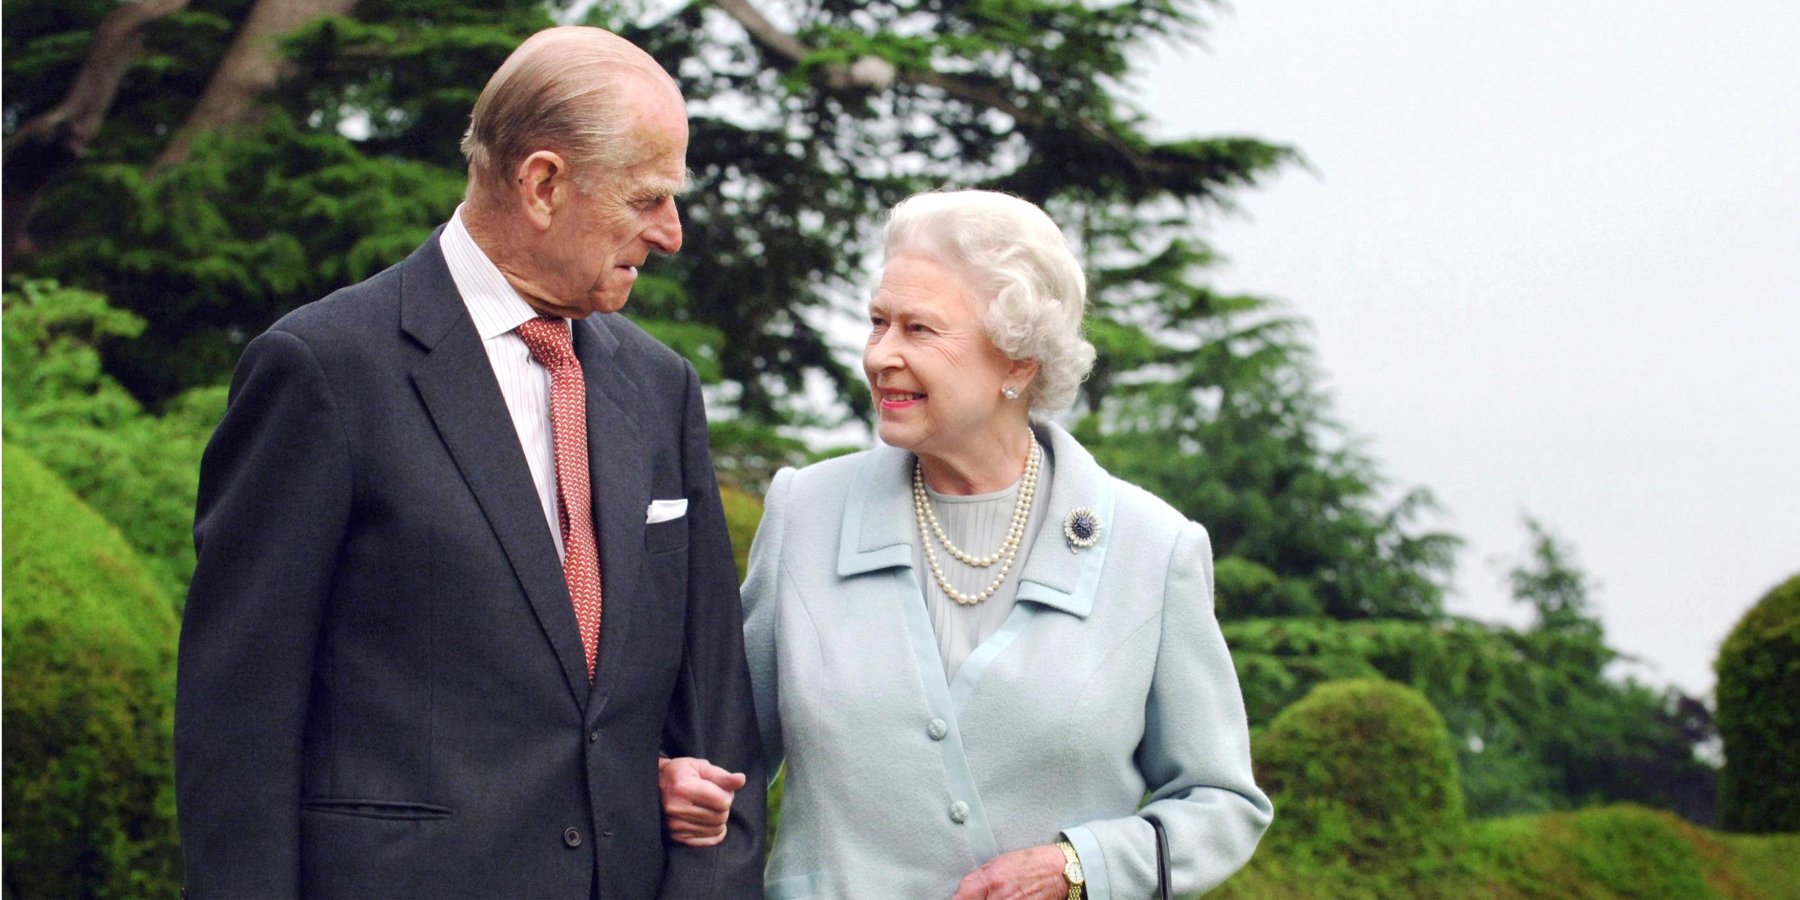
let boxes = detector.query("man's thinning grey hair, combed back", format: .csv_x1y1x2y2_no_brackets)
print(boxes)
463,25,675,195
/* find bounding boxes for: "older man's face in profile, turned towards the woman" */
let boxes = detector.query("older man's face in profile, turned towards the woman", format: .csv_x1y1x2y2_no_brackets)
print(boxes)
540,83,688,319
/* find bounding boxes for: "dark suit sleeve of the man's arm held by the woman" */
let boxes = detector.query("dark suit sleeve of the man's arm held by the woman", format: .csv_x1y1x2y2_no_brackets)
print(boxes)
661,364,765,898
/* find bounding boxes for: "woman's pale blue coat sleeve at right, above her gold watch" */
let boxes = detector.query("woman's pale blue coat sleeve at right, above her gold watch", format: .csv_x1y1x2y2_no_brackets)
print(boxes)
1064,522,1274,900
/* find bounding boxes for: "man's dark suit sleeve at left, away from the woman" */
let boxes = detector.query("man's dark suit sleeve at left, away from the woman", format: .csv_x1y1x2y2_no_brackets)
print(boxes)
175,331,353,898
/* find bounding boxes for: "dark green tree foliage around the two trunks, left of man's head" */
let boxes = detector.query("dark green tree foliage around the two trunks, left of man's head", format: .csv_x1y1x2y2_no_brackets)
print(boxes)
4,0,553,407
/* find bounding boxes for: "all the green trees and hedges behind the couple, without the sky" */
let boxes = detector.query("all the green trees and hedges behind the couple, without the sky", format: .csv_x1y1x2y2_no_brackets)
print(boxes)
4,0,1800,896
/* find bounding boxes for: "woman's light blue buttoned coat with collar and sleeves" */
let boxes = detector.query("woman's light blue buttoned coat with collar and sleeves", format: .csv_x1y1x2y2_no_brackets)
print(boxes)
743,423,1273,900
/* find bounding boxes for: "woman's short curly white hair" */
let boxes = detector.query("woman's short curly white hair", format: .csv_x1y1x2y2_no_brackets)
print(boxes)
886,191,1094,412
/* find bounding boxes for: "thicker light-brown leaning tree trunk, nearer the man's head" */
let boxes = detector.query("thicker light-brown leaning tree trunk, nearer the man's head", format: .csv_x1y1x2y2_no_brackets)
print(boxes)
157,0,356,167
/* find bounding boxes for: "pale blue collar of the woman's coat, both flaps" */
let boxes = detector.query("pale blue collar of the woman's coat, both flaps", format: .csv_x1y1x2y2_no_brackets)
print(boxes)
837,421,1112,617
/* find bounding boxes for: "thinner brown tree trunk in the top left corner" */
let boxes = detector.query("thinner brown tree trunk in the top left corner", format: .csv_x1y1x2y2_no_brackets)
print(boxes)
0,0,187,268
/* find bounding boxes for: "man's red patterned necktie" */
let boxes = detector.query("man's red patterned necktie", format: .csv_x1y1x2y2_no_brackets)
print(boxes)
518,315,599,680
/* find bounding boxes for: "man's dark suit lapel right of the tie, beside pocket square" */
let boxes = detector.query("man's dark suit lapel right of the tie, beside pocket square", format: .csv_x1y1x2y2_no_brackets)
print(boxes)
574,315,652,706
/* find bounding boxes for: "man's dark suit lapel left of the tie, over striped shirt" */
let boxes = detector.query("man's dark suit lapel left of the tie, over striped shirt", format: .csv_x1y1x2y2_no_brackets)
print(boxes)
400,234,589,704
